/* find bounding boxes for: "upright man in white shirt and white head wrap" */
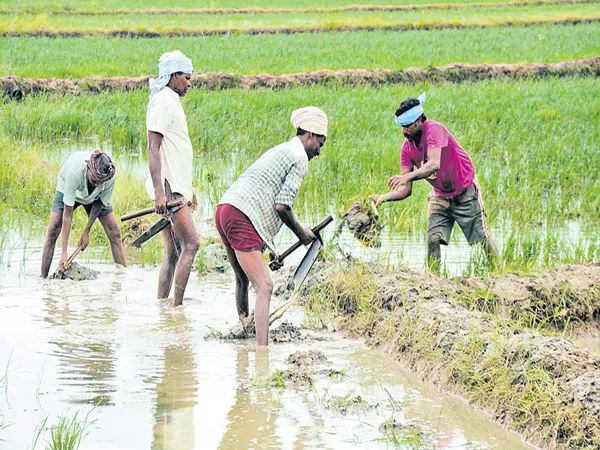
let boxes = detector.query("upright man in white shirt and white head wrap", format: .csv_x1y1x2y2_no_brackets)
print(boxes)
146,50,200,306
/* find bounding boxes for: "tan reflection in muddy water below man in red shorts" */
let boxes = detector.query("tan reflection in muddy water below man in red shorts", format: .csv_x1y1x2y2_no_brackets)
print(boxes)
219,347,281,450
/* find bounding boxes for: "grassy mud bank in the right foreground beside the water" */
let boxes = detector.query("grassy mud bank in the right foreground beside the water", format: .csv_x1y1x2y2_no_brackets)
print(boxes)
303,262,600,449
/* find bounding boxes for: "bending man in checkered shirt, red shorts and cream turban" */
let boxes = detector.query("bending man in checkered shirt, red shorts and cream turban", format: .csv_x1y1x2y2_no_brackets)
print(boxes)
215,106,327,346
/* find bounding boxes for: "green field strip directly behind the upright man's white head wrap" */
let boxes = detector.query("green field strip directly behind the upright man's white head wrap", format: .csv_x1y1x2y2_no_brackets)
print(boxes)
0,23,600,78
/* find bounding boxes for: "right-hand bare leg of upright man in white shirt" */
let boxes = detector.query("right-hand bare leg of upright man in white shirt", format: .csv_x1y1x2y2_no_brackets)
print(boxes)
166,206,200,306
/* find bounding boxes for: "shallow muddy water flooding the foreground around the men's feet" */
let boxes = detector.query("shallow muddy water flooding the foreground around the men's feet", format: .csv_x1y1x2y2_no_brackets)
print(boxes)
0,250,527,450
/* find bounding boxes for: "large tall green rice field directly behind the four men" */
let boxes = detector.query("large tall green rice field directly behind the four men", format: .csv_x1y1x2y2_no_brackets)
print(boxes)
0,79,600,239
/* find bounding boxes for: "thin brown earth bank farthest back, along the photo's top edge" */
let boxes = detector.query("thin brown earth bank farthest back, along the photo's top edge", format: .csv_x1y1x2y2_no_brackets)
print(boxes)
0,0,598,16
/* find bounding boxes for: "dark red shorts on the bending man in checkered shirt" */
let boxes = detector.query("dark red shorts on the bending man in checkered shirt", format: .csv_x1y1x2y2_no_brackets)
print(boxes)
215,203,265,252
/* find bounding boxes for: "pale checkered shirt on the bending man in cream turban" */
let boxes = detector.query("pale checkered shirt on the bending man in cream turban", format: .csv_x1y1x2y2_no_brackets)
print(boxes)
219,137,308,250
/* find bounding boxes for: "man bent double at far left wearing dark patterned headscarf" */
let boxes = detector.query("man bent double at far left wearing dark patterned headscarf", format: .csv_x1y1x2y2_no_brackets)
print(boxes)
42,150,125,278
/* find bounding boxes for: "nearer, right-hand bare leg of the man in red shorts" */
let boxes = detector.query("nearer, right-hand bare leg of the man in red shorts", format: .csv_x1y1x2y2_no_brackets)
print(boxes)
234,250,273,346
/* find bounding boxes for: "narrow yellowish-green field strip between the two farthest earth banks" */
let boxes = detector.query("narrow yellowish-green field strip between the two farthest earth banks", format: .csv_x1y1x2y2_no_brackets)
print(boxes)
0,3,600,35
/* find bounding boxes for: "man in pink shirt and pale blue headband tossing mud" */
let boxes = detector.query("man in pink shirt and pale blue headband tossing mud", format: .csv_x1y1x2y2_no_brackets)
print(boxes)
375,93,496,271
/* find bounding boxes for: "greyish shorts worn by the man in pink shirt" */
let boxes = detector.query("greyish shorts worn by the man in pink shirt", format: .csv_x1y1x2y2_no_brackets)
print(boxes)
427,181,489,245
